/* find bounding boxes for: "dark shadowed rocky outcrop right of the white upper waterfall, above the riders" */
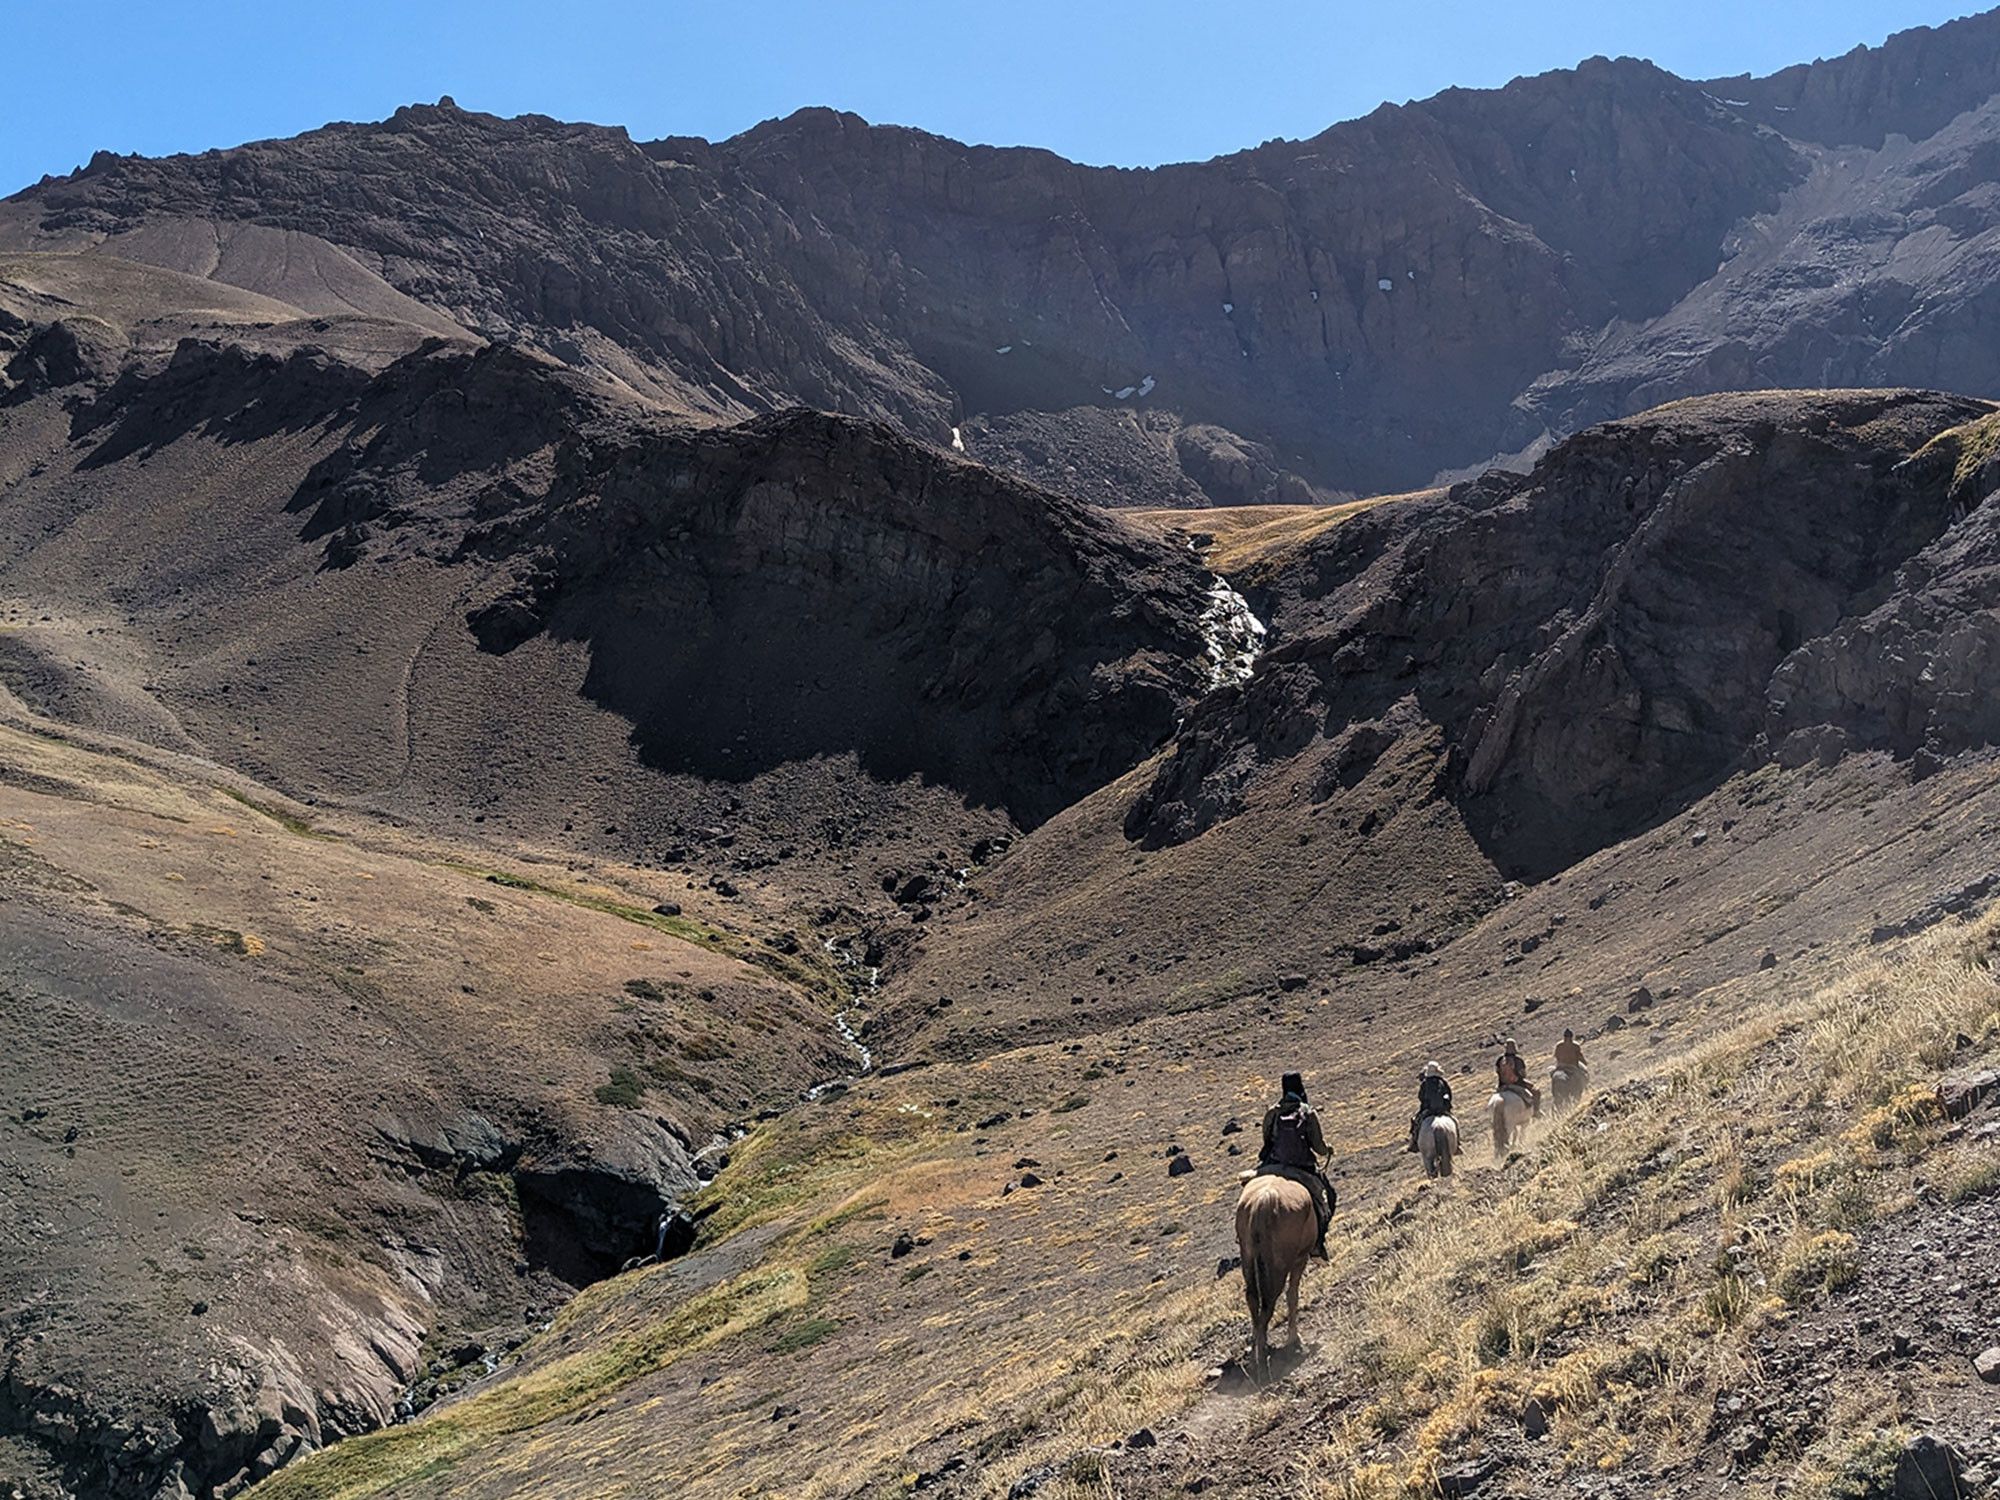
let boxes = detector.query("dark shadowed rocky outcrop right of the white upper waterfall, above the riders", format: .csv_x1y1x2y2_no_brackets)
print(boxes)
1126,392,1992,878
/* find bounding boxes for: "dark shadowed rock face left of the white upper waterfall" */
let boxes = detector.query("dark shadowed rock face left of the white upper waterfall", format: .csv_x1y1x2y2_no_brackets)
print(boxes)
0,304,1212,826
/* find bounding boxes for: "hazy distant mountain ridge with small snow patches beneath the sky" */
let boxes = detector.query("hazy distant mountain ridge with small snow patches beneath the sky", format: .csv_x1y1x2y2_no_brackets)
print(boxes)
19,16,2000,504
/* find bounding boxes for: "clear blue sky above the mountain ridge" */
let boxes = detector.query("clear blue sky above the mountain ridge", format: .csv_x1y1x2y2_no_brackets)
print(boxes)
0,0,1974,194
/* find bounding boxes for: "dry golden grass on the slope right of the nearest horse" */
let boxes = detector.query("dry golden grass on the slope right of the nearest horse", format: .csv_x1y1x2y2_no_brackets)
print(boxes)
1308,914,2000,1500
